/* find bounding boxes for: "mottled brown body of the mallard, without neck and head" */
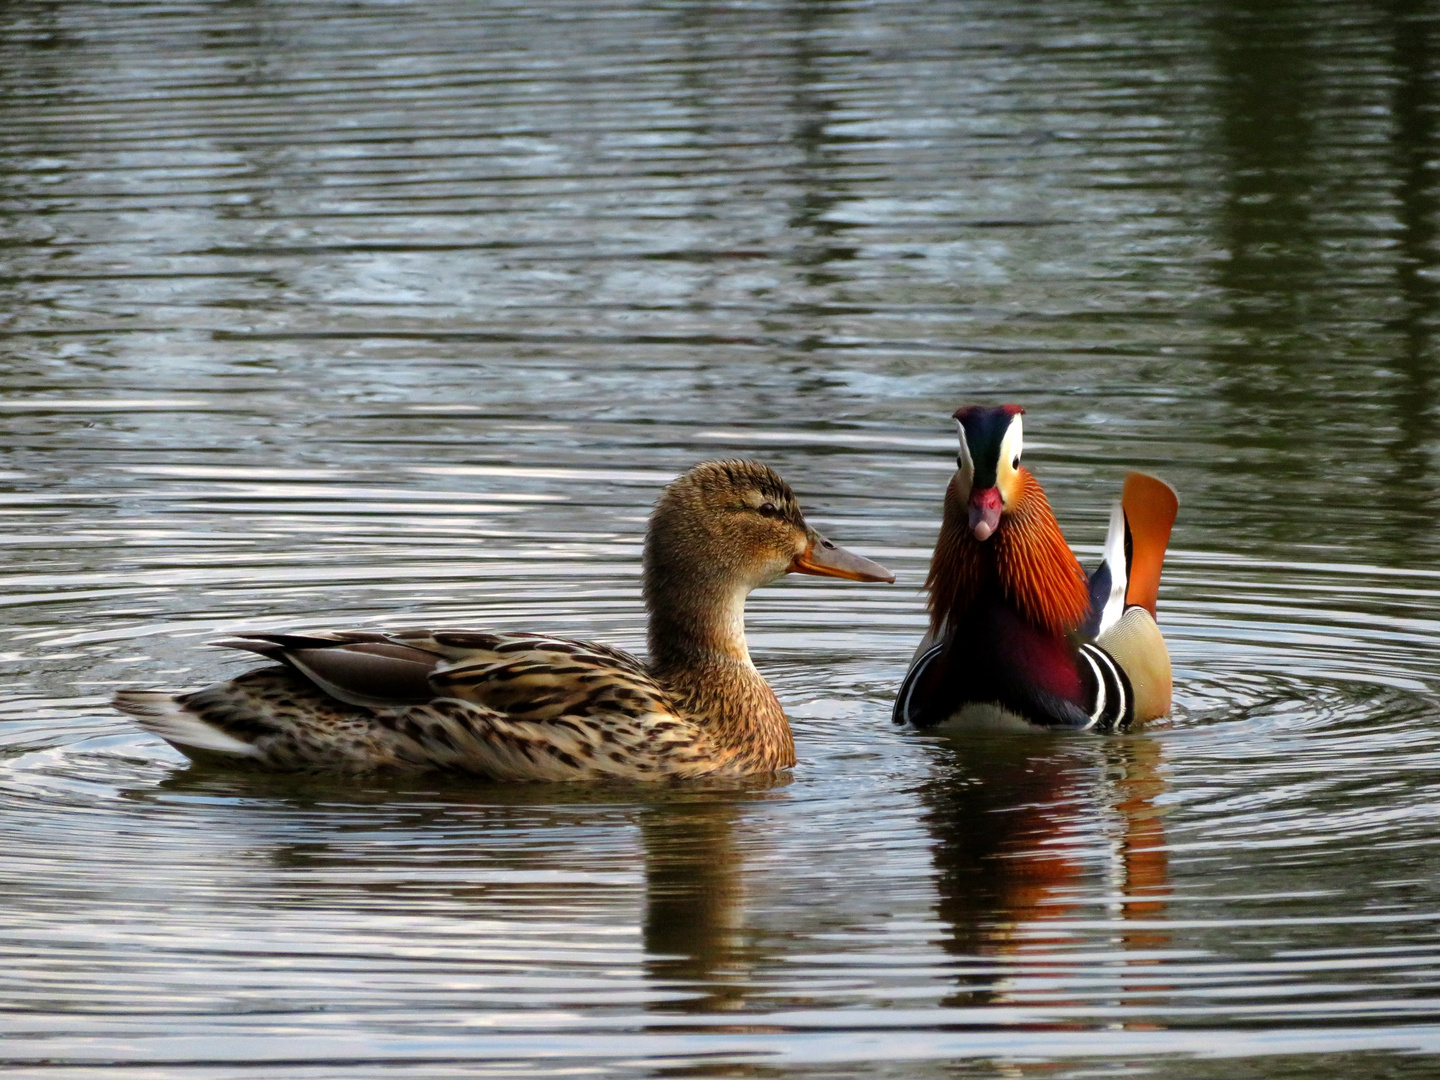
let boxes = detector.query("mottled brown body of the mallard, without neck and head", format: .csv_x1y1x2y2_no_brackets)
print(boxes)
115,631,727,780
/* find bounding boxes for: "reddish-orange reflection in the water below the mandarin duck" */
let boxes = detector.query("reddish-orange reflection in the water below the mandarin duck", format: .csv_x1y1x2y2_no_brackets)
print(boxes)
920,736,1169,1005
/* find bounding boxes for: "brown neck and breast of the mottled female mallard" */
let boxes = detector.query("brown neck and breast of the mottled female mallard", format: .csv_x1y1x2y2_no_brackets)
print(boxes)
645,573,795,769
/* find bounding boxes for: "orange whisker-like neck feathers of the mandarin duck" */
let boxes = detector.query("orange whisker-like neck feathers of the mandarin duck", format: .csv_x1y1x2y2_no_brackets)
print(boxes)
924,469,1090,635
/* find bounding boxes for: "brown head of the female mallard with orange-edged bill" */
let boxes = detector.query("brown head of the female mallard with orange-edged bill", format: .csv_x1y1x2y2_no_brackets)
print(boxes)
645,461,894,600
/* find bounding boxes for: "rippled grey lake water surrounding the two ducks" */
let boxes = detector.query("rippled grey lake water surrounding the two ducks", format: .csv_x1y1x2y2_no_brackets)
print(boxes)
0,0,1440,1080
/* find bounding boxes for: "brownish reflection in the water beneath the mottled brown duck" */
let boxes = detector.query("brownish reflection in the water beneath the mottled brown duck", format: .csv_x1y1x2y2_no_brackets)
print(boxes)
128,765,789,1014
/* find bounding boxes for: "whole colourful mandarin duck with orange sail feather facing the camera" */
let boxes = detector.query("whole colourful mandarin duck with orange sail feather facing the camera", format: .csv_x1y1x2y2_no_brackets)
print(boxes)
894,406,1176,732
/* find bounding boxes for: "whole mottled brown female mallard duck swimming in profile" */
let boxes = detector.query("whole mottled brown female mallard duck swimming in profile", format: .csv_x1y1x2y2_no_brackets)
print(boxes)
115,462,894,780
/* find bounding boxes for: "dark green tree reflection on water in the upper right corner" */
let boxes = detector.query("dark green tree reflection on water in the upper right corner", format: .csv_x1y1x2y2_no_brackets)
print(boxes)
1210,0,1440,550
